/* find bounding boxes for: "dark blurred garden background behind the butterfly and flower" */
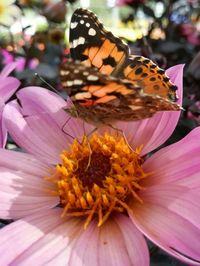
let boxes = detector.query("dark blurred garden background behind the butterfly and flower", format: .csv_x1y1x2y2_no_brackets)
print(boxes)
0,0,200,265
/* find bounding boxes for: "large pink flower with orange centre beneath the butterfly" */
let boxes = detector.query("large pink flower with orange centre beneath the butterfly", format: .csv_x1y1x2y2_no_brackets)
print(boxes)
0,65,200,266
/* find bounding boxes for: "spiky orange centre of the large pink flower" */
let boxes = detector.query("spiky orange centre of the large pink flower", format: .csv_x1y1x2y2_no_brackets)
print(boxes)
46,133,149,228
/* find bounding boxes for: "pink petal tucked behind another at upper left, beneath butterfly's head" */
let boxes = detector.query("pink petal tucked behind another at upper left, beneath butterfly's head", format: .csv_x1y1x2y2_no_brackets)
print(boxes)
17,87,94,142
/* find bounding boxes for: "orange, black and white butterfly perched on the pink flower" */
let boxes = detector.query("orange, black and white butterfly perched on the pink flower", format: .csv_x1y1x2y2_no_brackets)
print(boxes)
60,8,181,124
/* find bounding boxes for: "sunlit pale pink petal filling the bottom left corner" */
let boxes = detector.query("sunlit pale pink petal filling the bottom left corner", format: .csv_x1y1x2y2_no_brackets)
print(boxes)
0,209,83,266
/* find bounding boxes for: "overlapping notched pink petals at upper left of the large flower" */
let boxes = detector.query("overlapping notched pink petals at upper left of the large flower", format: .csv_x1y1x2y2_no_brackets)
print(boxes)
4,87,94,163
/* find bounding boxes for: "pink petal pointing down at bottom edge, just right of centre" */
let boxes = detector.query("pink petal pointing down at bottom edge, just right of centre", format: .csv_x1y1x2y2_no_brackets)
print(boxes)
98,217,148,266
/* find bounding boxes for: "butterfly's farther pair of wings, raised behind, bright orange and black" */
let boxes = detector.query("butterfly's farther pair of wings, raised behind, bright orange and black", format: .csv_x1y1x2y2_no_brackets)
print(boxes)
70,9,177,101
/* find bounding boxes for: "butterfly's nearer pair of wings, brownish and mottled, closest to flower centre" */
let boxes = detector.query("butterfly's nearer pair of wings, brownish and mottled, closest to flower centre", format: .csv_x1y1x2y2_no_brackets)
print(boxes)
60,60,180,124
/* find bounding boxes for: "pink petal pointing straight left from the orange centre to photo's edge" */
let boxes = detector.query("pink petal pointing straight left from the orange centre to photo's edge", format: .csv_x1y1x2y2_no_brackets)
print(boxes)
0,149,59,219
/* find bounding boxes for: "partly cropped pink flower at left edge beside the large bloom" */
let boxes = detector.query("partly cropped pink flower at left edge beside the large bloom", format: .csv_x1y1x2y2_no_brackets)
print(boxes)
0,63,20,147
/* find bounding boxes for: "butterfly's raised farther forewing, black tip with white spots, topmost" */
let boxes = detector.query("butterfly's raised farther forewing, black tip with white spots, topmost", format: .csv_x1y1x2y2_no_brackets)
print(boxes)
70,8,129,76
